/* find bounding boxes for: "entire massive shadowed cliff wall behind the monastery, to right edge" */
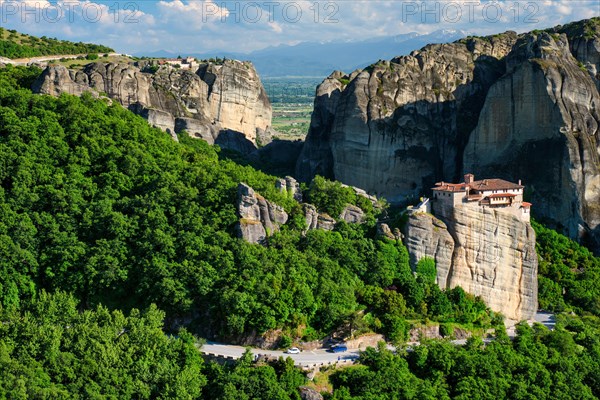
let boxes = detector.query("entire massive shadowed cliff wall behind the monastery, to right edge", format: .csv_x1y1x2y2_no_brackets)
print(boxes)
296,18,600,249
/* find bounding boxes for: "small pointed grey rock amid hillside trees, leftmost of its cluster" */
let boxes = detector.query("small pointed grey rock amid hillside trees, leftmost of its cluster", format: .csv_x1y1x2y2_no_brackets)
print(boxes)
237,183,288,243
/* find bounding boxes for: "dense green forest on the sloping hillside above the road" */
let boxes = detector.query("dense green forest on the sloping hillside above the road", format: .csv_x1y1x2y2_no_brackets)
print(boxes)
0,64,490,338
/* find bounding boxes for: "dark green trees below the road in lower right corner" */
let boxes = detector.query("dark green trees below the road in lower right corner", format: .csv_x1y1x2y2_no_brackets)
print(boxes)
331,316,600,400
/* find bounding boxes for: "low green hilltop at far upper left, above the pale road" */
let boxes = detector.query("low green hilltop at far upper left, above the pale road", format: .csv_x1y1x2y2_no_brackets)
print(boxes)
0,28,114,59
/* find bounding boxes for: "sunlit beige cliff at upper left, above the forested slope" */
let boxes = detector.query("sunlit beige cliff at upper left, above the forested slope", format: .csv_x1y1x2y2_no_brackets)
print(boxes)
32,60,272,153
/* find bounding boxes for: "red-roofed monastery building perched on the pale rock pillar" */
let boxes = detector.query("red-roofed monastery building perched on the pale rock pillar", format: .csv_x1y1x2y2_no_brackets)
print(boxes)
432,174,531,222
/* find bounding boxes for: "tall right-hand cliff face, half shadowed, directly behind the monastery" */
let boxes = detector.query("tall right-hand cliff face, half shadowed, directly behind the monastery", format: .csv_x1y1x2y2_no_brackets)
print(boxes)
464,33,600,252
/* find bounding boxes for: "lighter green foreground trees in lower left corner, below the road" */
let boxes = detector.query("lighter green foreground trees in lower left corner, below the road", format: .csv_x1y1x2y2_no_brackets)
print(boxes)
0,291,306,400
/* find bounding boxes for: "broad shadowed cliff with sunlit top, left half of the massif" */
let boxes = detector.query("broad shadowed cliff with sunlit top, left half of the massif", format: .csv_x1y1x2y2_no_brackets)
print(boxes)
297,32,517,202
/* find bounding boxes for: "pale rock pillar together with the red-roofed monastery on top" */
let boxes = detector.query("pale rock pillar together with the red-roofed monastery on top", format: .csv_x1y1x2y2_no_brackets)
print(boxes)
403,174,538,321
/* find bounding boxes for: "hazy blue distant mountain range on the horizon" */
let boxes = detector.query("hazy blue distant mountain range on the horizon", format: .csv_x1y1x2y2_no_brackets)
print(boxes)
138,30,470,77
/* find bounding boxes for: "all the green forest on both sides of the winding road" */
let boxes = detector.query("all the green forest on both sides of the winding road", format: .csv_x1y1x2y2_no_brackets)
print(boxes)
0,66,600,399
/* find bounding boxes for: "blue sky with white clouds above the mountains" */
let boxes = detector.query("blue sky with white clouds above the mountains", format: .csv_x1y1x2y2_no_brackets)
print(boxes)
0,0,600,55
